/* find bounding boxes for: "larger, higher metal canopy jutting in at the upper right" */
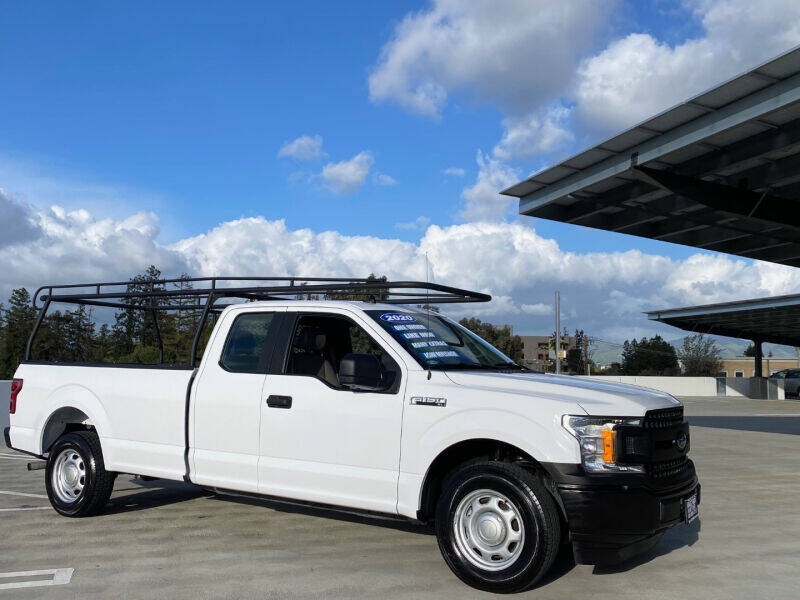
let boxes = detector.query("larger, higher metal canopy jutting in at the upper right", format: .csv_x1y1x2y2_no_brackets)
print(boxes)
502,47,800,266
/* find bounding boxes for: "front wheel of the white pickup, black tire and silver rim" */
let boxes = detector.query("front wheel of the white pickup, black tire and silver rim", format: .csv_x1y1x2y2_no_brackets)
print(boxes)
436,461,561,593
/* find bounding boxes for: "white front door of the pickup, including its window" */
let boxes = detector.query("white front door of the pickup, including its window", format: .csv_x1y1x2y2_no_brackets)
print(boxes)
258,312,405,513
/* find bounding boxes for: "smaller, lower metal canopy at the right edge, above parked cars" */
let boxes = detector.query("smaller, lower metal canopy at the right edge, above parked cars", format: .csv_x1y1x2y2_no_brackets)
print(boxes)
646,294,800,346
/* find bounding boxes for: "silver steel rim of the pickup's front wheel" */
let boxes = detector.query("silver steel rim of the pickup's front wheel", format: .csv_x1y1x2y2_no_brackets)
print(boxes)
453,489,525,571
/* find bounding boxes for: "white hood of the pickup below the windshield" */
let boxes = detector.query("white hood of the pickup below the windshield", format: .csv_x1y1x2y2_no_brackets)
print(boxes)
445,371,680,417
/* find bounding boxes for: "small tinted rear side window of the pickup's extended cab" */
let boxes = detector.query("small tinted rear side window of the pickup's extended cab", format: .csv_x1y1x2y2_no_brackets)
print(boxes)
219,313,275,373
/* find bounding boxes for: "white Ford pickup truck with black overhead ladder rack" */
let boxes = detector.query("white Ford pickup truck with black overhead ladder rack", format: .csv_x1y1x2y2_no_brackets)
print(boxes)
5,282,700,592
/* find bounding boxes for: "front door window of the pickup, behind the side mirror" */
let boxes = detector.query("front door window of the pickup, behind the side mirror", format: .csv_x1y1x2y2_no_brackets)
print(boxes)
286,315,400,391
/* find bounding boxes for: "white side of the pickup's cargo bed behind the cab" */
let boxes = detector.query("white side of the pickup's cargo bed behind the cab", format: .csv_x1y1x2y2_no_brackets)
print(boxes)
10,362,193,479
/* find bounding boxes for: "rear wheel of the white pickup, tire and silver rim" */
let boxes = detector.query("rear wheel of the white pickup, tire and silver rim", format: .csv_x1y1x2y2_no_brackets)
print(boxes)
45,431,116,517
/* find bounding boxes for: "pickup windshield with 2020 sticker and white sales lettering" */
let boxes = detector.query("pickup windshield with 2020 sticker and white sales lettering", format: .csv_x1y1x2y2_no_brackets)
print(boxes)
366,310,524,370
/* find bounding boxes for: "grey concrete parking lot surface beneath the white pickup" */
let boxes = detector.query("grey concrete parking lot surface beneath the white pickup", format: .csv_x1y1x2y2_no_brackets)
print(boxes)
0,398,800,600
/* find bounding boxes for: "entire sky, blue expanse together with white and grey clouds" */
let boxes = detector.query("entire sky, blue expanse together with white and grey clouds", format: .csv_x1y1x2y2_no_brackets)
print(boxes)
0,0,800,338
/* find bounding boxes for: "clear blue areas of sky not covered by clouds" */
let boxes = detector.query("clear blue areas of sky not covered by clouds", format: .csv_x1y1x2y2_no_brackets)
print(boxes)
0,2,697,248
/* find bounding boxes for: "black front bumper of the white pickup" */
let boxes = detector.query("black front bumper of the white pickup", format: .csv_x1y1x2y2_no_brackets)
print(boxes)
545,461,700,565
